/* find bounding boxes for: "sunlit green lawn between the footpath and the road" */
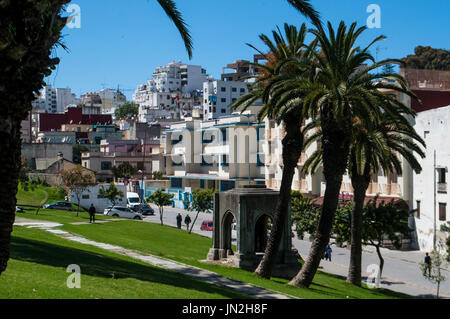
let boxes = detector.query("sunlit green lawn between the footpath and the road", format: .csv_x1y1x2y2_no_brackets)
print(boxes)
62,221,409,299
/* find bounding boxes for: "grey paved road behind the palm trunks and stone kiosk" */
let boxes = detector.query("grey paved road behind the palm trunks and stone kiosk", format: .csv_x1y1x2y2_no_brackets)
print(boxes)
145,206,450,298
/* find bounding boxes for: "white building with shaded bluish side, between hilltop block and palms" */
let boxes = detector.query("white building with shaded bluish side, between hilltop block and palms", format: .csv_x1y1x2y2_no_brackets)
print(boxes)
203,80,248,120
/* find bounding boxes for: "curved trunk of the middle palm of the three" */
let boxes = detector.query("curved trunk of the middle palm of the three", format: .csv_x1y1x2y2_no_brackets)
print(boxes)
289,133,349,287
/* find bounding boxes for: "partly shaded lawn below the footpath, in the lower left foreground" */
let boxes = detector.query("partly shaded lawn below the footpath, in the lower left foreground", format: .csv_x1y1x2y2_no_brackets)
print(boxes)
0,226,248,299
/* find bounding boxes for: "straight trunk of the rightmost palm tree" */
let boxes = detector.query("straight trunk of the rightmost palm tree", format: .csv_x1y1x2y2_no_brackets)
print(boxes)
347,174,370,287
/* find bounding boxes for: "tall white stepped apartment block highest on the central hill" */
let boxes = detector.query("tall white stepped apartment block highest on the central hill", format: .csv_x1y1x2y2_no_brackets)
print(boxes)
133,62,208,122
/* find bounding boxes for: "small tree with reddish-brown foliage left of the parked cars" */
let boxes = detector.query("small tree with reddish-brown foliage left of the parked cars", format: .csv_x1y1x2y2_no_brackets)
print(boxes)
60,165,95,217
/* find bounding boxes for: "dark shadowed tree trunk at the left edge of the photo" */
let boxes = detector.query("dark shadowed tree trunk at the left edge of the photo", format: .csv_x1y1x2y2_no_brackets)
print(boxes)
0,116,21,275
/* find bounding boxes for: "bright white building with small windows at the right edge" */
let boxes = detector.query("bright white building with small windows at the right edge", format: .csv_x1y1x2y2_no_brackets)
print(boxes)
413,106,450,251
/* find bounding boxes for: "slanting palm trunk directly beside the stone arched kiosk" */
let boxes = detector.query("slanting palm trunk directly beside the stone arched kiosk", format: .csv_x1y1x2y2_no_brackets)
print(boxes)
255,119,303,278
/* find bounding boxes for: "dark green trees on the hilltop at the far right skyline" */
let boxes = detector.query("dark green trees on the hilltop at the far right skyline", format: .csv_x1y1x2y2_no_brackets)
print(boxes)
403,45,450,71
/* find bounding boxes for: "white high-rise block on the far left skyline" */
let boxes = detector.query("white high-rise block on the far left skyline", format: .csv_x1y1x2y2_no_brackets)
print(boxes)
32,85,80,113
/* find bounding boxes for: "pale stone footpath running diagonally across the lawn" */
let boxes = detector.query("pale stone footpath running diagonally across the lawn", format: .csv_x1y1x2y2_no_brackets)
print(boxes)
14,218,295,299
